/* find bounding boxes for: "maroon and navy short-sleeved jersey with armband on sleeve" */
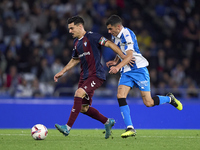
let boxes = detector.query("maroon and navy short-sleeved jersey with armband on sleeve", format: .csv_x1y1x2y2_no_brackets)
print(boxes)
72,31,107,80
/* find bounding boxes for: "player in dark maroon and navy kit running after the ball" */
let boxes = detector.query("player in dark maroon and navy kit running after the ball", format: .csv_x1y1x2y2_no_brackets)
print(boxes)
54,16,132,139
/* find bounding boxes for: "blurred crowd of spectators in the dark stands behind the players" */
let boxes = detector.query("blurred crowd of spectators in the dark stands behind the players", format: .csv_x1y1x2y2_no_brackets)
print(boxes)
0,0,200,98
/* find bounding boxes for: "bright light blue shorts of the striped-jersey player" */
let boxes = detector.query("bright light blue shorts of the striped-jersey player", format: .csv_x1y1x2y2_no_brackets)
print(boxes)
118,67,150,91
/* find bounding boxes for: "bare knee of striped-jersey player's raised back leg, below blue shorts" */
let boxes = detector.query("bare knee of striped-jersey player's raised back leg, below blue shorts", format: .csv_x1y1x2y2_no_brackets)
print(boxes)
140,91,154,107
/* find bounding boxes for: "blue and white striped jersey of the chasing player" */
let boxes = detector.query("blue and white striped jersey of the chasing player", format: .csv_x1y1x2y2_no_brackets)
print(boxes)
112,27,149,73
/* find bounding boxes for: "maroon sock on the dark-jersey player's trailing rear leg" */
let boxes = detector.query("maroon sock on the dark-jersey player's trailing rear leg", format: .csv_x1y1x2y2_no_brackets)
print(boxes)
83,107,108,124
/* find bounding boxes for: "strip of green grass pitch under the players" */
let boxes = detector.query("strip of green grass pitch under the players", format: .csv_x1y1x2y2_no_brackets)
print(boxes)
0,129,200,150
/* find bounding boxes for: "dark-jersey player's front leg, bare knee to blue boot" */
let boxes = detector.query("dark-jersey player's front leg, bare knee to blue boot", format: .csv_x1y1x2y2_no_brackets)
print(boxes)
55,88,86,136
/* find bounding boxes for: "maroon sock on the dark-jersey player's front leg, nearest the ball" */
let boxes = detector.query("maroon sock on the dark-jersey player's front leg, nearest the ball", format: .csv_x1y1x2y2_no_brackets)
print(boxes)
67,97,82,127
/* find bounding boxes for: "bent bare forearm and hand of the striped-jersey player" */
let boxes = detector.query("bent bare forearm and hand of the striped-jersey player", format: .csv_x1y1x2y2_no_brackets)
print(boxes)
109,50,133,74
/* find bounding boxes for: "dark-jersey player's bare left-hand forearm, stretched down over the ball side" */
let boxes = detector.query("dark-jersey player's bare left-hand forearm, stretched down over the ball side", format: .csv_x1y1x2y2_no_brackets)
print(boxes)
54,58,80,82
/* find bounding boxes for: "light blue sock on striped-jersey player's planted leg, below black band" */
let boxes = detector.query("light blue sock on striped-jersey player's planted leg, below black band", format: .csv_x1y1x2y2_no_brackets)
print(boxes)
119,105,133,126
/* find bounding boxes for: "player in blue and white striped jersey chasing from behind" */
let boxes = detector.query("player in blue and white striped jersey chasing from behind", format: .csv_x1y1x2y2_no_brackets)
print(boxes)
106,15,183,138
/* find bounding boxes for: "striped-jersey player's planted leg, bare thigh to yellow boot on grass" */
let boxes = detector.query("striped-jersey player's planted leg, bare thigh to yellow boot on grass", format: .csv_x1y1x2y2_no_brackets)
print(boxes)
117,85,136,138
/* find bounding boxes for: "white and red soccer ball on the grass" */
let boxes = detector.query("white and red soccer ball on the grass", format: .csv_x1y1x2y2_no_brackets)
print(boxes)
31,124,48,140
